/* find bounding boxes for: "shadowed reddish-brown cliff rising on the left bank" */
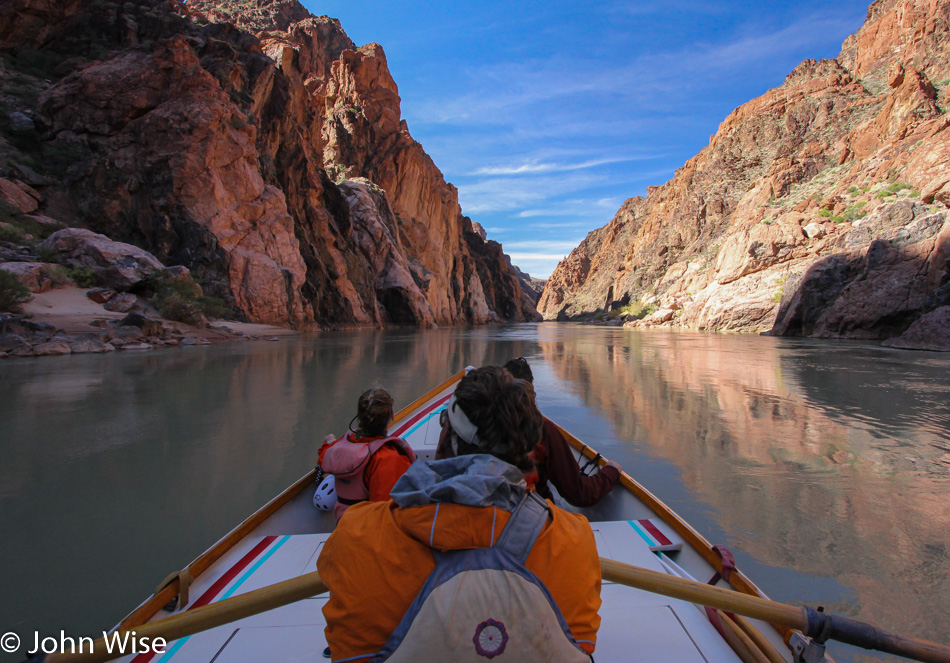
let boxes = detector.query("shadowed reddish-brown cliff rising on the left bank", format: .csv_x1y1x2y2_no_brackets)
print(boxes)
0,0,536,327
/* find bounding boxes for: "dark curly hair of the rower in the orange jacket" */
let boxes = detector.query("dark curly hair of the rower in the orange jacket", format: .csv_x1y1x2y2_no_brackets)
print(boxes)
455,366,542,472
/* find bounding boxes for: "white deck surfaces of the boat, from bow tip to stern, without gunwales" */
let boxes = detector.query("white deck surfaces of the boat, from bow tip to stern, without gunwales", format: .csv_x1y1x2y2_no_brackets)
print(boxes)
120,376,784,663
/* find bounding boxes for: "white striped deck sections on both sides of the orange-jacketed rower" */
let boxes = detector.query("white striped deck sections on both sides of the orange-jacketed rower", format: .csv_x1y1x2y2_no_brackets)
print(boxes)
117,528,738,663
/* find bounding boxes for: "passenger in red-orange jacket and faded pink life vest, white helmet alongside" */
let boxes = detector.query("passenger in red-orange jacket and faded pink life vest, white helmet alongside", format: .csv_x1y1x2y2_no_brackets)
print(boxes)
319,388,416,520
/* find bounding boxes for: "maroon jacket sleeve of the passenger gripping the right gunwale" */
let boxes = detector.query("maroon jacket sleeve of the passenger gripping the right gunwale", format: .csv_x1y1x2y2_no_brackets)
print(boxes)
538,417,620,506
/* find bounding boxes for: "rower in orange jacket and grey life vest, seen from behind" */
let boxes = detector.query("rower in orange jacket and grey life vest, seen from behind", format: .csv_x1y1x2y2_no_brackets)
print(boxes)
317,366,601,662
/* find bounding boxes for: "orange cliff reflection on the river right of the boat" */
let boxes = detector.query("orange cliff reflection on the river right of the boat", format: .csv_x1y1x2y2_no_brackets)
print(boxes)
541,333,950,641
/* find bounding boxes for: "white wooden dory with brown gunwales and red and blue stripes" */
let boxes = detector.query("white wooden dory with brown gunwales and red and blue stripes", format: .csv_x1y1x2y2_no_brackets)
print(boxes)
54,372,944,663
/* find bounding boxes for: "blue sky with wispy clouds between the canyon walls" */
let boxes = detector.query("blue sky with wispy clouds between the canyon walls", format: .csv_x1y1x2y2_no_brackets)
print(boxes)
303,0,869,278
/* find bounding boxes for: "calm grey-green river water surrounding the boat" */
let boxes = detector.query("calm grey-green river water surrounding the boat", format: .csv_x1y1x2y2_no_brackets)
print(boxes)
0,323,950,661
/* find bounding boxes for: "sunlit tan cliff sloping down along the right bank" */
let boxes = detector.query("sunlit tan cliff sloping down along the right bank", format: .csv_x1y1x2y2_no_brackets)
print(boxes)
538,0,950,346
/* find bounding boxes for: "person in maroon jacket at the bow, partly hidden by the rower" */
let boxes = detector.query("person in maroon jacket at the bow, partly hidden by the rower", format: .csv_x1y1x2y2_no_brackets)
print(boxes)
505,357,622,507
